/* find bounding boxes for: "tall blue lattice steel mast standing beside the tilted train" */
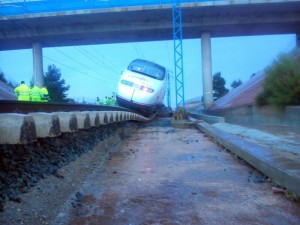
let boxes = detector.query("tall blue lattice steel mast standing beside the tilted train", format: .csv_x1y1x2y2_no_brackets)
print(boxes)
172,0,185,112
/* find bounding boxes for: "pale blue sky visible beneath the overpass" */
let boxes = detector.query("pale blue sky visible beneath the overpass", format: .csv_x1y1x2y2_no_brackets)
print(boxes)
0,35,296,105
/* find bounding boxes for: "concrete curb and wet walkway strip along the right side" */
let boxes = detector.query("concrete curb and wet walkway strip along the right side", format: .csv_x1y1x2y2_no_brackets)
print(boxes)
191,119,300,196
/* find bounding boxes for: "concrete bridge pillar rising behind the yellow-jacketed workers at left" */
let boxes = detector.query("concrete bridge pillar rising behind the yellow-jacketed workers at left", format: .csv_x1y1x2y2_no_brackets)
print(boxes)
32,42,44,87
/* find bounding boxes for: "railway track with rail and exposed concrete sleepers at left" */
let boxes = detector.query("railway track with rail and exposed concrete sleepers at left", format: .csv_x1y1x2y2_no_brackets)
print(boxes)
0,101,163,145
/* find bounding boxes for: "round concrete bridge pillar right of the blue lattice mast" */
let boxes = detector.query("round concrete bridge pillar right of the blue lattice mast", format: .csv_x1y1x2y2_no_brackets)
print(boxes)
201,32,213,109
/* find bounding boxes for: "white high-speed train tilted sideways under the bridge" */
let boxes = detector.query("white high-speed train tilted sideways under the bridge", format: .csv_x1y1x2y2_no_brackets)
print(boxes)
116,59,168,116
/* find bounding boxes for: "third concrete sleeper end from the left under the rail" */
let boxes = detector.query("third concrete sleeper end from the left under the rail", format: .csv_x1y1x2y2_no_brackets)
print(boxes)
55,112,78,133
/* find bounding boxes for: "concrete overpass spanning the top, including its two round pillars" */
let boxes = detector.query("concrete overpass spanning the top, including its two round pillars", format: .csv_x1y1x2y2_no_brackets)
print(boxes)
0,0,300,107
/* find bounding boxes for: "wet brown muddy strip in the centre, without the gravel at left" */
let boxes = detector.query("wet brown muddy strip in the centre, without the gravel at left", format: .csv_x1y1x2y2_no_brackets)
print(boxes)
62,119,300,225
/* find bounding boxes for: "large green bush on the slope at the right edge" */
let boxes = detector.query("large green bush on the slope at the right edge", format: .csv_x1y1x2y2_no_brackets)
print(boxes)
256,54,300,106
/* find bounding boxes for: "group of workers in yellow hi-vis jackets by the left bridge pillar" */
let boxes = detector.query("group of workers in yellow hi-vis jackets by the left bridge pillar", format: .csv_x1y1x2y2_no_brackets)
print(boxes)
15,81,49,102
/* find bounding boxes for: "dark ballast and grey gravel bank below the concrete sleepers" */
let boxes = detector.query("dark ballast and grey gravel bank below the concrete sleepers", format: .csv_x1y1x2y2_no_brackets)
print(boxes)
0,123,136,224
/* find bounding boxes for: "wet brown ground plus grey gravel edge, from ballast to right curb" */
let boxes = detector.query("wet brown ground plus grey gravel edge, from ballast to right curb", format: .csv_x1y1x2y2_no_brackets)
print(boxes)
0,118,300,225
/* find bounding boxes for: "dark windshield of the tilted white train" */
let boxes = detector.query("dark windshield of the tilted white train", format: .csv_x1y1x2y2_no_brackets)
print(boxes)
128,59,166,80
